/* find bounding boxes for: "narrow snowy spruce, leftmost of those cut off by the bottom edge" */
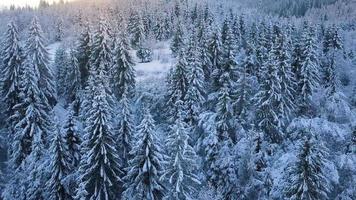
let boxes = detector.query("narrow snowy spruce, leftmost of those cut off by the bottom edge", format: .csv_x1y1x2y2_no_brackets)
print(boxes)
46,127,72,200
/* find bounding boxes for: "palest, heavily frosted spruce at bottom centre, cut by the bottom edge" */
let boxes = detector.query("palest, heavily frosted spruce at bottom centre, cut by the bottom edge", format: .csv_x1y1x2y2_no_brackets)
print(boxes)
162,101,200,200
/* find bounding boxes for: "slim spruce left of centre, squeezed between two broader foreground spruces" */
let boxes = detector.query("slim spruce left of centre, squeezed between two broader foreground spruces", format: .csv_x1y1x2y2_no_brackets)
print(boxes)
116,89,135,168
